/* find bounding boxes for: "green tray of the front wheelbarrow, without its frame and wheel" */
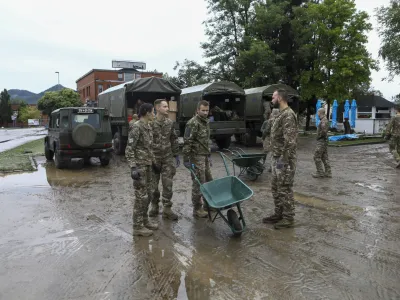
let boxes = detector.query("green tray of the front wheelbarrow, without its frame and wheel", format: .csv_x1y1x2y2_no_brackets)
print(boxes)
200,176,253,209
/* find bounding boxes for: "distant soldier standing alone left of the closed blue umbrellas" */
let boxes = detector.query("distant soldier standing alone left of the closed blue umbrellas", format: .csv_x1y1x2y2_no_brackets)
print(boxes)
312,108,332,178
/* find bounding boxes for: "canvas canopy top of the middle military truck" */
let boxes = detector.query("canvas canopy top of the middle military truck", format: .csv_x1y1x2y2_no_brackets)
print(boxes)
182,81,245,95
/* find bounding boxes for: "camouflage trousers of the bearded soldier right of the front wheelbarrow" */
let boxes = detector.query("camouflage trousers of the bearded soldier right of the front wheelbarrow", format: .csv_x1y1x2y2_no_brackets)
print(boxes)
271,157,296,220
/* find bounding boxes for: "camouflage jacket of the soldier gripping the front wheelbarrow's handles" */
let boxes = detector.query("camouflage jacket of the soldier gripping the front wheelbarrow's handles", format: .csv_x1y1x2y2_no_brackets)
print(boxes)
183,115,211,160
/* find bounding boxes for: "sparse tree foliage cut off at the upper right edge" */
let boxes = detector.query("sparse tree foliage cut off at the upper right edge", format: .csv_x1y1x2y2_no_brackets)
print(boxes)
375,0,400,81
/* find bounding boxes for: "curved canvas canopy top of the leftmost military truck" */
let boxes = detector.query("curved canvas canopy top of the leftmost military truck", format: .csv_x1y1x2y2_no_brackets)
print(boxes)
99,76,181,96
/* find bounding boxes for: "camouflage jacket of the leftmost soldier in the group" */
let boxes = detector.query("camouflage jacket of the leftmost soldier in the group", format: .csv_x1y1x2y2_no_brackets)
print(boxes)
125,120,155,168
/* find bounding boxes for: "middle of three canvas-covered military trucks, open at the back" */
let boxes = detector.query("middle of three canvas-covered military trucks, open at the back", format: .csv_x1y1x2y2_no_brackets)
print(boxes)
178,81,246,149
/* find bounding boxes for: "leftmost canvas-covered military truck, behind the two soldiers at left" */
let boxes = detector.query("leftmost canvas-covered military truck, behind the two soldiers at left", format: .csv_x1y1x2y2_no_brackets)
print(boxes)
98,77,181,155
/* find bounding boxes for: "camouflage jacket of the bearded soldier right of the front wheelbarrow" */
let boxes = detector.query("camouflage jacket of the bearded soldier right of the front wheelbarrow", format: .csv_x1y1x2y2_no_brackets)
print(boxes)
271,107,298,162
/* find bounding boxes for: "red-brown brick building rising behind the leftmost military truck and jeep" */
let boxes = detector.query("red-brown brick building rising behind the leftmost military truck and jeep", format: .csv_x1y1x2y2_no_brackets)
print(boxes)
76,69,163,103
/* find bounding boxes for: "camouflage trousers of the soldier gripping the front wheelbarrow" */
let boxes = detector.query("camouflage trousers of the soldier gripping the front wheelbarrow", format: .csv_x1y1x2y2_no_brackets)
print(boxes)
190,155,213,209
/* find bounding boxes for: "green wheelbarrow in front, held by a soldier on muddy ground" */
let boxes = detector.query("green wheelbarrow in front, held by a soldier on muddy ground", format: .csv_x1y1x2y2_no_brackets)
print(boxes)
190,152,253,236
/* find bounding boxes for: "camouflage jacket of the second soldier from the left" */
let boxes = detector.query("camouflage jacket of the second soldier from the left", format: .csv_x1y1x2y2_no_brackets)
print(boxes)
151,118,179,159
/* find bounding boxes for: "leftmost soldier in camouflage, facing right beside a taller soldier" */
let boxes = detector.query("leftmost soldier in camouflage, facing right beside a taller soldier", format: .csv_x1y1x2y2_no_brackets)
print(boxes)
125,103,159,236
